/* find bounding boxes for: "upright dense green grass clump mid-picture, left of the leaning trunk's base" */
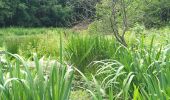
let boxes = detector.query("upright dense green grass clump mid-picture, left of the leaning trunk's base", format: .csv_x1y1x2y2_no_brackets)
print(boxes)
65,35,118,72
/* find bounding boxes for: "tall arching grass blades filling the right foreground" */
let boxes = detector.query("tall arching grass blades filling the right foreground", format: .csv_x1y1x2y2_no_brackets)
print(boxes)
76,38,170,100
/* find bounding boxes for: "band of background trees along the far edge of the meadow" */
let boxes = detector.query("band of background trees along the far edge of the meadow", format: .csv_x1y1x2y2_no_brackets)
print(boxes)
0,0,170,28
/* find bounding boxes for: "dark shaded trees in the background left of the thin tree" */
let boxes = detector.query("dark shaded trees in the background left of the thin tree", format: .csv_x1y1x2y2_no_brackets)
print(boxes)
0,0,96,27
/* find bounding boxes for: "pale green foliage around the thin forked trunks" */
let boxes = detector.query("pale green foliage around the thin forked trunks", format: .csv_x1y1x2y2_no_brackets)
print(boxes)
92,0,142,34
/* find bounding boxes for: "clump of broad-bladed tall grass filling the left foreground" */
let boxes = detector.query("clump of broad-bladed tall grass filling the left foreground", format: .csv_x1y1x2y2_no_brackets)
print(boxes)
0,34,73,100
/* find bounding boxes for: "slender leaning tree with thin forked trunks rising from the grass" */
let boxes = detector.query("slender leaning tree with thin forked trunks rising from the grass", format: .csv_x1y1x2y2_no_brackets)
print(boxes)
110,0,128,47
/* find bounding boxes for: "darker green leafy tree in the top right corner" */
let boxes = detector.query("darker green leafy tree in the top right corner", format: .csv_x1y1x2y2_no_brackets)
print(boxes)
143,0,170,28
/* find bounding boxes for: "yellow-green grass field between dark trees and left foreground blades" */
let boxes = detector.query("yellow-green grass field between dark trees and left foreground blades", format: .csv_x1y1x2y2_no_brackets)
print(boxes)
0,28,75,58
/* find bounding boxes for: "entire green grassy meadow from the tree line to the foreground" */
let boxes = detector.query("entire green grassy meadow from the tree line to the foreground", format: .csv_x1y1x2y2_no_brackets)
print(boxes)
0,27,170,100
